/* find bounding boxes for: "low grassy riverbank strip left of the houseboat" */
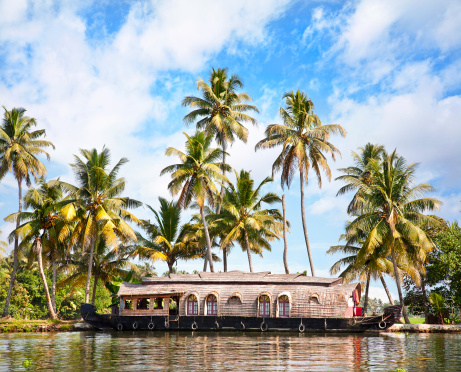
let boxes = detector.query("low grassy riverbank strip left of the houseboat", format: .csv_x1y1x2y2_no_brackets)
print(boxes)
0,319,94,333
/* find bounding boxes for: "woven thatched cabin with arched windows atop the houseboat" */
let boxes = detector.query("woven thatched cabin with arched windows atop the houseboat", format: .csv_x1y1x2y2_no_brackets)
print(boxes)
118,271,361,318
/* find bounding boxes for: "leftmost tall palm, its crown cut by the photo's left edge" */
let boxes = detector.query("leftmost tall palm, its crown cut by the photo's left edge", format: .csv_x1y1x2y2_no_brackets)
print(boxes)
0,106,54,316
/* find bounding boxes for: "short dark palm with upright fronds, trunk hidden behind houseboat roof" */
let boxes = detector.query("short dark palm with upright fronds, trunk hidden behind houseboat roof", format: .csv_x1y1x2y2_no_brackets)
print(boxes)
132,197,206,272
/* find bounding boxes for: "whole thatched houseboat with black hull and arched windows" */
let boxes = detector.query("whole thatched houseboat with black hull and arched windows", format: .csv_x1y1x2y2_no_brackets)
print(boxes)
81,271,401,332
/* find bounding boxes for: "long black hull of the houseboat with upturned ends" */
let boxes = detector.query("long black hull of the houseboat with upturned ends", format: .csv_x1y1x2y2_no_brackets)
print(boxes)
81,304,396,332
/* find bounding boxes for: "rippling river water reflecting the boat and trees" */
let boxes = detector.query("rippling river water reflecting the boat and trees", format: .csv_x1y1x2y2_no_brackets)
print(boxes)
0,331,461,371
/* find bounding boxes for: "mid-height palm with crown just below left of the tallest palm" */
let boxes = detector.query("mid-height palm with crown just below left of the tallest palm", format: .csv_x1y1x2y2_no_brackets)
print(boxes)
160,132,230,272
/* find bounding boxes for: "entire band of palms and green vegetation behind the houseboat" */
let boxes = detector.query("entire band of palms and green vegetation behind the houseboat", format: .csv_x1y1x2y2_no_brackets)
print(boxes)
0,68,454,330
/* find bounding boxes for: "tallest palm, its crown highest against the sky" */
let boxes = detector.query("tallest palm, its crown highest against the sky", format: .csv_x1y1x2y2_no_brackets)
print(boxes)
182,68,259,271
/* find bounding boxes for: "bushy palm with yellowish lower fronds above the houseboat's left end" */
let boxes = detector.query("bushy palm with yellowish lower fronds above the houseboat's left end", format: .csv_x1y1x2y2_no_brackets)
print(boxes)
63,147,141,302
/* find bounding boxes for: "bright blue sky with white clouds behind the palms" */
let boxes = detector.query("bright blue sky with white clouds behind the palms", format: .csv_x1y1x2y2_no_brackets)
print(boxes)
0,0,461,300
